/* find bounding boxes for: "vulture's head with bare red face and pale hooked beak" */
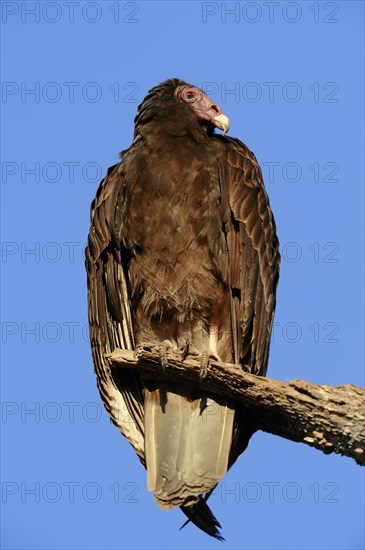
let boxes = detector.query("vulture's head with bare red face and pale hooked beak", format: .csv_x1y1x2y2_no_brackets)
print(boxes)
134,78,229,141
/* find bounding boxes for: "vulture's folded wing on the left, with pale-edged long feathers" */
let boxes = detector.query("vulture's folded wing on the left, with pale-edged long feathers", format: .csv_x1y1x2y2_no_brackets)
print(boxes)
85,164,144,464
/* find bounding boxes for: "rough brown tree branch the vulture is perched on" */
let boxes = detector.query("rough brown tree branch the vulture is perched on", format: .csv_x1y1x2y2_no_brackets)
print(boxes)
108,346,365,465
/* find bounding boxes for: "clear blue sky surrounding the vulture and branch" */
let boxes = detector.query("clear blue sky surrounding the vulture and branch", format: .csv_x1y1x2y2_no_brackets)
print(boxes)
1,1,364,550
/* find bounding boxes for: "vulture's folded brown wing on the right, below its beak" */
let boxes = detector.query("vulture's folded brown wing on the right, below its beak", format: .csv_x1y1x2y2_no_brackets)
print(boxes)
220,138,280,376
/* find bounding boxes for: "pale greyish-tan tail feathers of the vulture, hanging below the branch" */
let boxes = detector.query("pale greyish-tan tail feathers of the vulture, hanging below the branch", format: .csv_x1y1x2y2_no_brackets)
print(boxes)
145,384,234,512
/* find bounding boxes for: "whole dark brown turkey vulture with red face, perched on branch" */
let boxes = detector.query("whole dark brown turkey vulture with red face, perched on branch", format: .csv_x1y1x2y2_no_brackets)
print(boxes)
86,78,280,539
